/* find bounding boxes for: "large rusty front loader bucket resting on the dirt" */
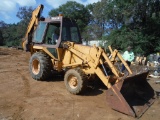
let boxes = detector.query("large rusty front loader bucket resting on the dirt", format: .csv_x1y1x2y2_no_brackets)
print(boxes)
107,71,155,117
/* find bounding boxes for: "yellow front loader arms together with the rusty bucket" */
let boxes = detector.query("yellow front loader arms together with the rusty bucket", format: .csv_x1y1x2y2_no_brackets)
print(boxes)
63,42,154,117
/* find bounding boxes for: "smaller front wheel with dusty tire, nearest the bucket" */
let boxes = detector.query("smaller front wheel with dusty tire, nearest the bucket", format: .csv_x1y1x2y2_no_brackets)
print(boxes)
64,69,87,95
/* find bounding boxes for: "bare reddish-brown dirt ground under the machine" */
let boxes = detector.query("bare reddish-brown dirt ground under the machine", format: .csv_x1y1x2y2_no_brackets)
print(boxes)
0,47,160,120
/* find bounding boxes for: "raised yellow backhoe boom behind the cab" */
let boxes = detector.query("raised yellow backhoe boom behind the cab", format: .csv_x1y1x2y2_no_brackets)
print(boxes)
22,5,44,50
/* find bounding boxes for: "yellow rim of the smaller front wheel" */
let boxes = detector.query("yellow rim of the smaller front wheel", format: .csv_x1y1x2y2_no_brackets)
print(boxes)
68,75,78,89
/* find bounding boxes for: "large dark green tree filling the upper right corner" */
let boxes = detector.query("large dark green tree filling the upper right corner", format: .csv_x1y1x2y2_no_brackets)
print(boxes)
105,0,160,55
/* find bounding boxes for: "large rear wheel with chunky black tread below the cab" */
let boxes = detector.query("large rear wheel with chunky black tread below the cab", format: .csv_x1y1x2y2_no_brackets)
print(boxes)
29,52,52,80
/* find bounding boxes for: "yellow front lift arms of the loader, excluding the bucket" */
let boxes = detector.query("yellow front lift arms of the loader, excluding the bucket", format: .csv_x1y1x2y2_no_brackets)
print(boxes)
63,42,122,88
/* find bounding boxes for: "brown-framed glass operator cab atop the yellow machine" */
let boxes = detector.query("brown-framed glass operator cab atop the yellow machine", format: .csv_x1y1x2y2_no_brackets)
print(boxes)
33,16,82,48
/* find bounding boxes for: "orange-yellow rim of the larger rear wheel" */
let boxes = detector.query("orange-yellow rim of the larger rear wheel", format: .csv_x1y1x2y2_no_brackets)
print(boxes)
32,59,40,75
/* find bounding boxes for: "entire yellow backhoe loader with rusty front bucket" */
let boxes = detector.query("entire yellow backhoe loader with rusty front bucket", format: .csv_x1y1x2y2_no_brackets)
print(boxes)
22,5,155,117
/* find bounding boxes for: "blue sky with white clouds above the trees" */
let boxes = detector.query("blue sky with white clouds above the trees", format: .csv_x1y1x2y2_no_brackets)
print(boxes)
0,0,100,24
